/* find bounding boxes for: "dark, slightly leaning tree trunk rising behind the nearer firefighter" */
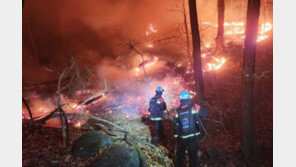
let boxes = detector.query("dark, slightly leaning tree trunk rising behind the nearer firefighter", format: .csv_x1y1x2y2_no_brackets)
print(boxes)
189,0,204,104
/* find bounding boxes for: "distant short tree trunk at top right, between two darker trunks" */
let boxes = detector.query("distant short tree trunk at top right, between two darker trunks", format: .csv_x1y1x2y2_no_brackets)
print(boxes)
216,0,225,51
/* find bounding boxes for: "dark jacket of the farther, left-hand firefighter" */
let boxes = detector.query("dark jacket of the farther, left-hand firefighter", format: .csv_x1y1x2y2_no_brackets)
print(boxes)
148,94,166,121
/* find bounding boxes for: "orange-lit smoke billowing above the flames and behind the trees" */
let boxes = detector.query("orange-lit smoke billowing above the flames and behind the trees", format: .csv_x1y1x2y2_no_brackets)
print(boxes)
23,0,272,98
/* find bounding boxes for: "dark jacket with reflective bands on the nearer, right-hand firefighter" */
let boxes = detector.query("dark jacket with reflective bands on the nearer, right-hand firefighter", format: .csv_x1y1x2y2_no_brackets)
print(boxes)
174,99,208,139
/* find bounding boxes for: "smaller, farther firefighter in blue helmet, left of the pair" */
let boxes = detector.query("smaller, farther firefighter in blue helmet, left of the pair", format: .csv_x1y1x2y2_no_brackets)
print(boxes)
148,86,166,146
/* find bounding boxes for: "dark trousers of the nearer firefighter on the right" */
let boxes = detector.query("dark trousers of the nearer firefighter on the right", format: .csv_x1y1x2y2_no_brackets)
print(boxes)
176,136,198,167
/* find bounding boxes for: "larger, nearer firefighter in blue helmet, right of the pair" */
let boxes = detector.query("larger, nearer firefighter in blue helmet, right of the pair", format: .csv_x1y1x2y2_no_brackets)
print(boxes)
174,91,208,167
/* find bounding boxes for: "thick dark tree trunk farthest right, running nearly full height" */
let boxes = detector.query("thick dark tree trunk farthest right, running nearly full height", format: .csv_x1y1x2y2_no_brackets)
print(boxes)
242,0,260,162
